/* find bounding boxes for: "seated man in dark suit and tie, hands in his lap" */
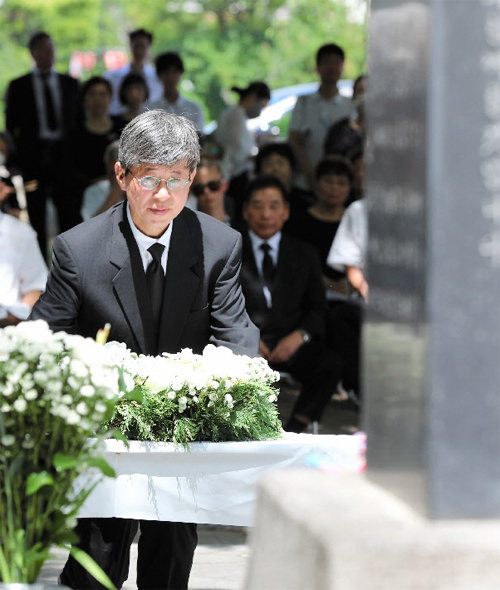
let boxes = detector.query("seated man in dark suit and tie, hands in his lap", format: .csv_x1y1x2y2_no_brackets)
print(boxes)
241,176,341,432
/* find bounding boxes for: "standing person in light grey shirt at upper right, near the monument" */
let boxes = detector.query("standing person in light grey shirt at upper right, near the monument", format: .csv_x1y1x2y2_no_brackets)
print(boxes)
289,43,356,190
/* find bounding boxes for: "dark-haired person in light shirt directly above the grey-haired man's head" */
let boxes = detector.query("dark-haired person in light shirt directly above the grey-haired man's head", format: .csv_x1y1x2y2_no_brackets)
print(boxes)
149,51,205,133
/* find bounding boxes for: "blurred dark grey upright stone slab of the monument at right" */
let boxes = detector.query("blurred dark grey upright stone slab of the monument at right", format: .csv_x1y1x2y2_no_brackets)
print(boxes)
364,0,500,518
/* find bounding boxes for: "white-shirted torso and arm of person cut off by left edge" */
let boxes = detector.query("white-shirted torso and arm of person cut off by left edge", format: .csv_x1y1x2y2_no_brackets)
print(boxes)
0,207,47,327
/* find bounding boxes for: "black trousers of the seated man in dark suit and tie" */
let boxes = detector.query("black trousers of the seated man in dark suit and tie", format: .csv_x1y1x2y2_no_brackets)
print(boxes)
273,340,342,421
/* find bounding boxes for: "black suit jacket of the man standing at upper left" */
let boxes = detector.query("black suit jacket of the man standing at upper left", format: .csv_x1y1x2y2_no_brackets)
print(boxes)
5,73,79,180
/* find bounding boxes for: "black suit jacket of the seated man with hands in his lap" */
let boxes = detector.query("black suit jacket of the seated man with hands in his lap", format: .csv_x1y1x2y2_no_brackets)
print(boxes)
241,234,326,349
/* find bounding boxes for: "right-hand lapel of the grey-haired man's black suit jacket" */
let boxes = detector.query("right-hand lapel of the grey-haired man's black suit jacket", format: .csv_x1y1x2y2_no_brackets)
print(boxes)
158,209,204,352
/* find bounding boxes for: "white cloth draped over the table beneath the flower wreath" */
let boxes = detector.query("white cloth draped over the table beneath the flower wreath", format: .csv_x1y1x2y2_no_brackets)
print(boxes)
77,433,364,526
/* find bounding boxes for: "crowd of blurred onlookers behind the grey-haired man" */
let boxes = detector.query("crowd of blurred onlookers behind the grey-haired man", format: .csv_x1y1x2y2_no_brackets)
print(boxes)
0,29,368,431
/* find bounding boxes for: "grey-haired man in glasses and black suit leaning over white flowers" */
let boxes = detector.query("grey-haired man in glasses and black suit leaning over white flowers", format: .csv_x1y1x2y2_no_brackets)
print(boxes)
31,110,258,590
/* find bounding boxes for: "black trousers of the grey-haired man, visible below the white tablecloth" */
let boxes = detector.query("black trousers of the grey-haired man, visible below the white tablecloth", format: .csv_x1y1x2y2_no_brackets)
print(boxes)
60,518,198,590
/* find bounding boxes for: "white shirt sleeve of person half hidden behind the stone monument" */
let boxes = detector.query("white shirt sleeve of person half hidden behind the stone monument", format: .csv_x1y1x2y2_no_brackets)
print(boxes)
327,200,368,271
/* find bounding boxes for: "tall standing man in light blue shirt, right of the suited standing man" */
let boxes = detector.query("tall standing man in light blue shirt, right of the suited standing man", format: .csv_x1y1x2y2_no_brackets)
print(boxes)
104,29,163,115
